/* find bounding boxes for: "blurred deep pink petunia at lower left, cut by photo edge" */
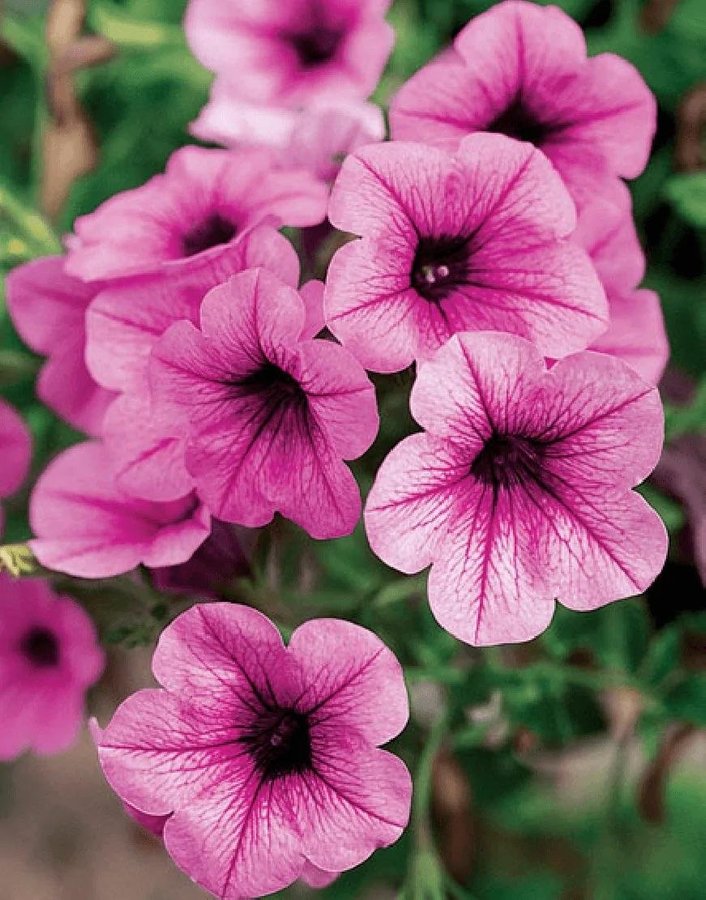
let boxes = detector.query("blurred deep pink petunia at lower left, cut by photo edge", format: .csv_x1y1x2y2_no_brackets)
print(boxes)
0,574,105,760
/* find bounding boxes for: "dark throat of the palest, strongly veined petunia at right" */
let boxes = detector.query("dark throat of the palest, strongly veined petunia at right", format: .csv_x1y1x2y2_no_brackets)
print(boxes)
471,433,544,491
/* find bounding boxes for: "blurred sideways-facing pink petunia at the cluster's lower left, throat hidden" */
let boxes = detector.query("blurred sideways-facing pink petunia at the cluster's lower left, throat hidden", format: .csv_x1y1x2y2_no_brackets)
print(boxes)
30,442,210,578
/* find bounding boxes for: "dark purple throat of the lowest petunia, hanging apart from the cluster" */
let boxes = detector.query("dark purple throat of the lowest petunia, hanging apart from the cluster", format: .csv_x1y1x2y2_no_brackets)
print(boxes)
239,709,312,781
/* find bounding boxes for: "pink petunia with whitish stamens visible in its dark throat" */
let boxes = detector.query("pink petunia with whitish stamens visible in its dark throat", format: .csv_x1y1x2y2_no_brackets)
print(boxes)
325,134,607,372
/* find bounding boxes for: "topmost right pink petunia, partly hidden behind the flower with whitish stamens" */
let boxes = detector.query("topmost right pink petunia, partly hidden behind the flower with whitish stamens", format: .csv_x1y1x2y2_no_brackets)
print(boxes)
390,0,657,214
